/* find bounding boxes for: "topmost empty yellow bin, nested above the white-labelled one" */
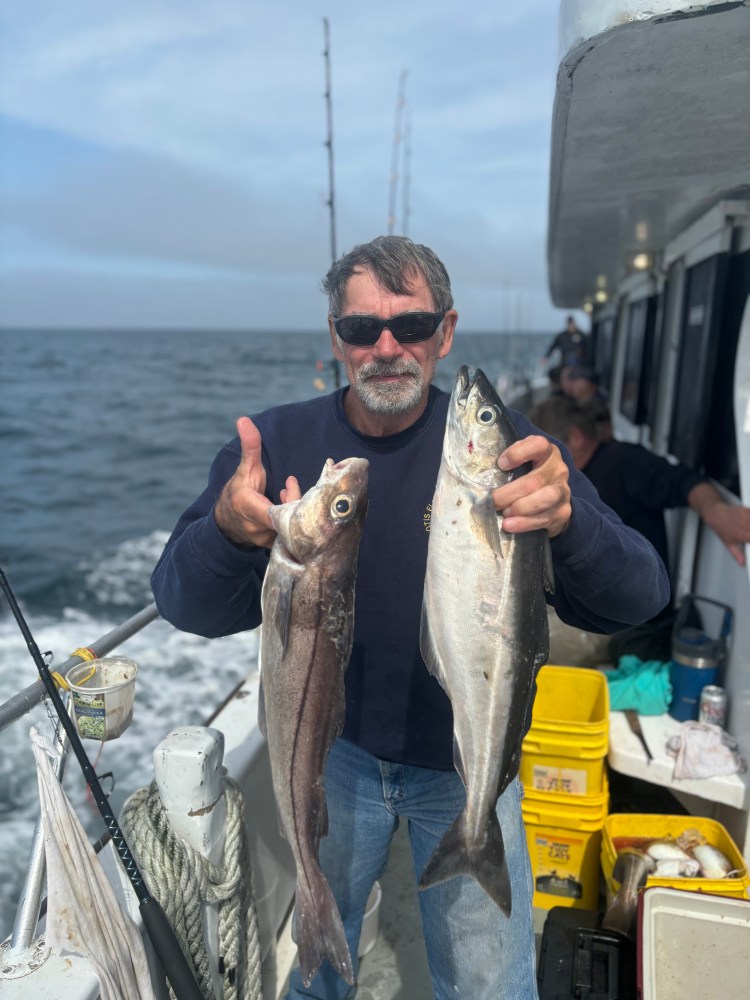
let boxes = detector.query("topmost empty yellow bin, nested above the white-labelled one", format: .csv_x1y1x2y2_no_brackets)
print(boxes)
531,664,609,740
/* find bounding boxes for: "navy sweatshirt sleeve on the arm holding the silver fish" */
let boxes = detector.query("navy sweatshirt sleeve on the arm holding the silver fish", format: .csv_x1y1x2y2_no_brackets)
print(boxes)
513,413,670,632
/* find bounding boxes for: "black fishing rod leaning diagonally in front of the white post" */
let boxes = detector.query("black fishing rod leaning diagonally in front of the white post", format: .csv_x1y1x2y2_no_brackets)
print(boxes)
0,567,203,1000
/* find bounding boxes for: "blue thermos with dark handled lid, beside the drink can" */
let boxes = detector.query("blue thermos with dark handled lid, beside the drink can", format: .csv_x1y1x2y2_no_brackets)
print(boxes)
669,594,732,722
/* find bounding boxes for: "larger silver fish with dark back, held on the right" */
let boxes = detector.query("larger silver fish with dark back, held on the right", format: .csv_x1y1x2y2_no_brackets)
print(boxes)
419,366,552,916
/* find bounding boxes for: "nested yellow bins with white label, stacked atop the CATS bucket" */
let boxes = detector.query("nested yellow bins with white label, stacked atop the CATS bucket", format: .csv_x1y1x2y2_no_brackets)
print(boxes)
519,666,609,795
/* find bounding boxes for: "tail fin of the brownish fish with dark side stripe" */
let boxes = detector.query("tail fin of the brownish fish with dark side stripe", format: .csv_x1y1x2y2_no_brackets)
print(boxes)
296,875,354,988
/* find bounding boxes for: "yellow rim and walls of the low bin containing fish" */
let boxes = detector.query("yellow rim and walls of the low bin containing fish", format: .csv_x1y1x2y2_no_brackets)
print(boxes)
601,813,750,901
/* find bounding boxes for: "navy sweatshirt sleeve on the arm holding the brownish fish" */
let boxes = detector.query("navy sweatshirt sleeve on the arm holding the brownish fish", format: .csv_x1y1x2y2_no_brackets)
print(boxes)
151,442,268,638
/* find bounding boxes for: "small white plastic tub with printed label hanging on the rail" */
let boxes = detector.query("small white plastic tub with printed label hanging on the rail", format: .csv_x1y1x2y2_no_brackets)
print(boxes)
65,656,138,741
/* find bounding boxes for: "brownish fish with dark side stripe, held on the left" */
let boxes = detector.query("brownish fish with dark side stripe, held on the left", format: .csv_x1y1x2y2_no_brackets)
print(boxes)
258,458,368,986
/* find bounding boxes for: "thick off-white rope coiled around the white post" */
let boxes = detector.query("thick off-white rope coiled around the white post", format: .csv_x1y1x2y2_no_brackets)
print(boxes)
120,775,263,1000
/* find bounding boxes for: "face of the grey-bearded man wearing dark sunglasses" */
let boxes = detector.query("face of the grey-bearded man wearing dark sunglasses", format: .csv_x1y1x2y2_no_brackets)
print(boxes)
329,269,457,426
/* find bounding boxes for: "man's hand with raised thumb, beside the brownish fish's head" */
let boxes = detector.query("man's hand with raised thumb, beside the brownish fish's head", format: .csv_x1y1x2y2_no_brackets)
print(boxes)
214,417,302,548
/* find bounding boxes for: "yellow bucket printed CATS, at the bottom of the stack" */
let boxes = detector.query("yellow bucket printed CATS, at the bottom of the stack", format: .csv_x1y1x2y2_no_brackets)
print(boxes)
521,776,609,910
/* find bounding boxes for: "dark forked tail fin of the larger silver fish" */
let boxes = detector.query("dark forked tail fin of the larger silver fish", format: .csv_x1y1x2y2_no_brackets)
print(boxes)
419,812,511,917
